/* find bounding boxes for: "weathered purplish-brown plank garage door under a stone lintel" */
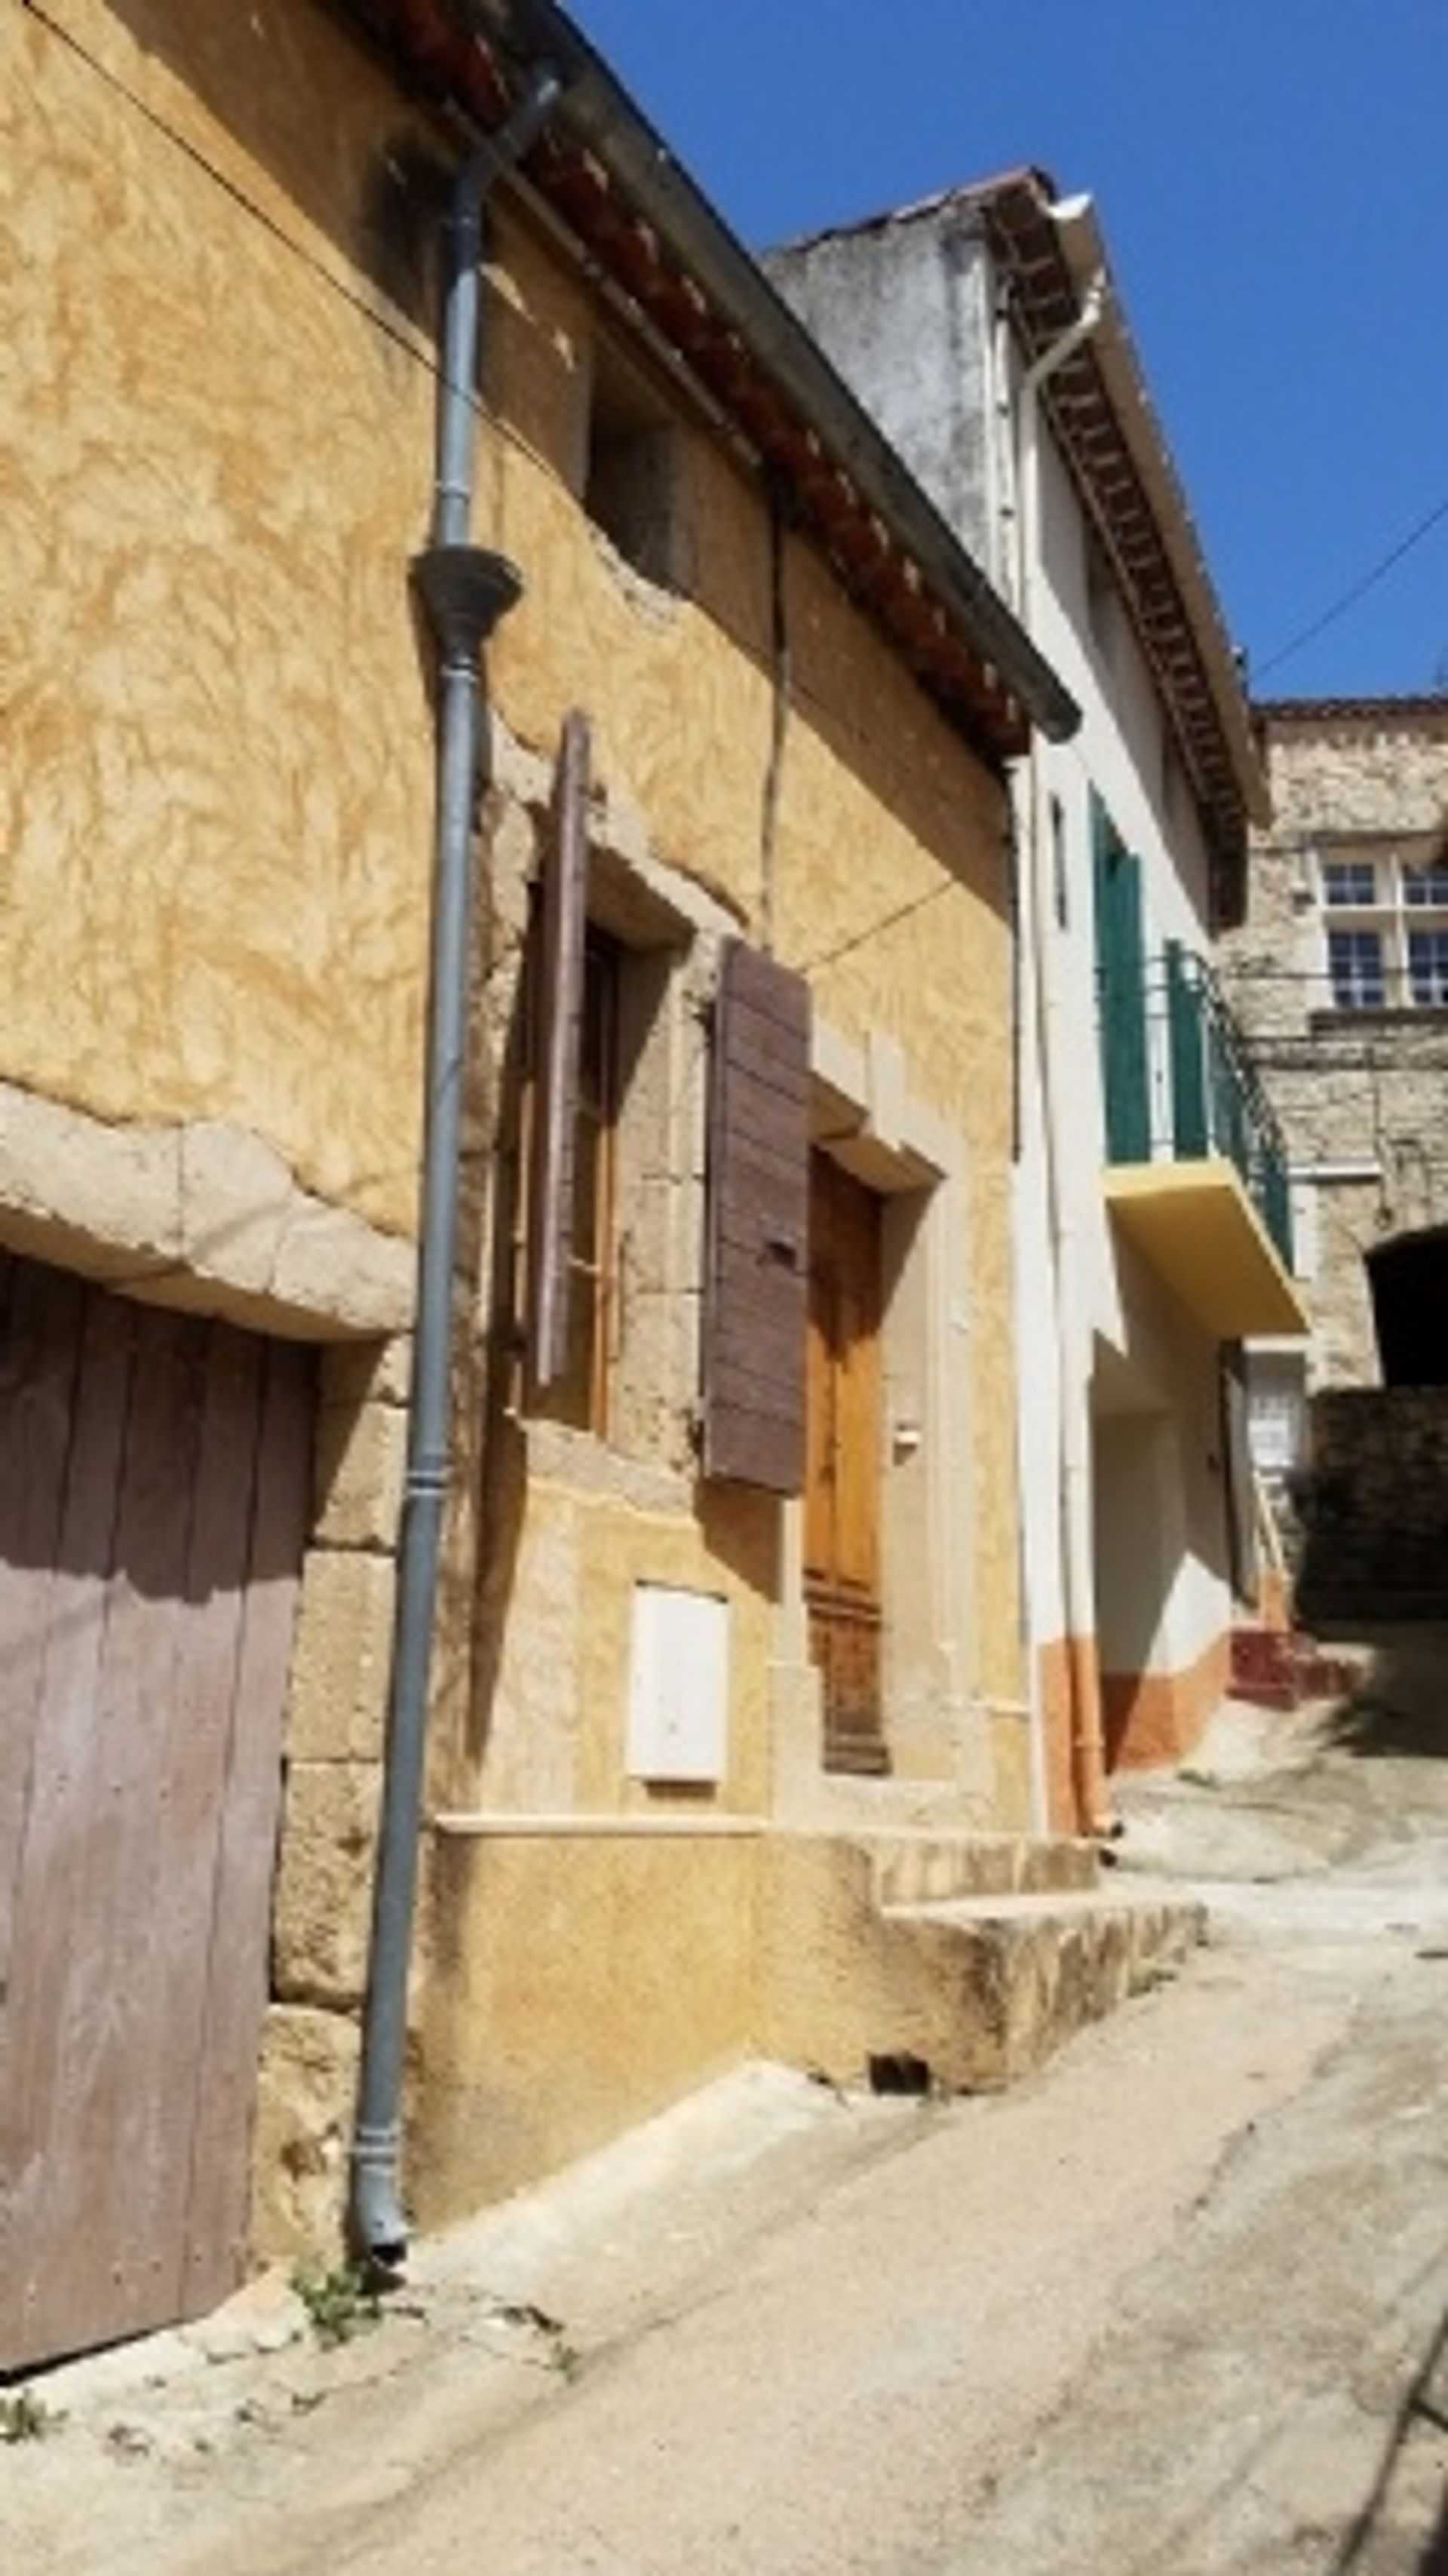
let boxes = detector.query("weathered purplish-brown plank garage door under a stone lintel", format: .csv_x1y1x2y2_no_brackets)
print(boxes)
0,1254,311,2370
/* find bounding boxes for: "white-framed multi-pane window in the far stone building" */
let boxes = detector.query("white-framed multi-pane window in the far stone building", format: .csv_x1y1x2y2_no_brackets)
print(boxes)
1317,834,1448,1010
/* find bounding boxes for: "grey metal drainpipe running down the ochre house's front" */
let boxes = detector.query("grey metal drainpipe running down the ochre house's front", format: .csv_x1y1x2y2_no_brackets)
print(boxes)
348,67,562,2270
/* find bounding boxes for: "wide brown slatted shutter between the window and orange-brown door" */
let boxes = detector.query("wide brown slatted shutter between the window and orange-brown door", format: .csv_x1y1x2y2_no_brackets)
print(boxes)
704,940,809,1494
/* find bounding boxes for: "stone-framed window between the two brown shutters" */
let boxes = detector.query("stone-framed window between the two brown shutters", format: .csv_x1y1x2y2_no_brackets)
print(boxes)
508,708,722,1476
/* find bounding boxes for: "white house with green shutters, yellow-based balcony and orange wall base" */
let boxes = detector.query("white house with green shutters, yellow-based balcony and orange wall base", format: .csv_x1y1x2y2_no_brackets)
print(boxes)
768,170,1304,1821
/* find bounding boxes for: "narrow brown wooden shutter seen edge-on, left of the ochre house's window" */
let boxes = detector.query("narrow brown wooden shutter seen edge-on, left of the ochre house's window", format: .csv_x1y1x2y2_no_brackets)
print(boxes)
528,708,587,1389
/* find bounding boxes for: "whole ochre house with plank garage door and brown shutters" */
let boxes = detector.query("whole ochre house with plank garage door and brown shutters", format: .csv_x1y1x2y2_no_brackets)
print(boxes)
0,0,1180,2367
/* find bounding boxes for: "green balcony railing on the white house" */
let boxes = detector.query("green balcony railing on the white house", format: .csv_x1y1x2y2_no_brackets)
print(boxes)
1100,940,1291,1273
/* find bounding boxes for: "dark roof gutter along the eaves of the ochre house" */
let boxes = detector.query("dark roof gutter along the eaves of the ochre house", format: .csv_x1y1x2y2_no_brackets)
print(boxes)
450,0,1079,742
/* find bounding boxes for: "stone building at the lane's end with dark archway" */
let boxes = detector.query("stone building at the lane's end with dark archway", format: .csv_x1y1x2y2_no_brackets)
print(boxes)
1224,698,1448,1633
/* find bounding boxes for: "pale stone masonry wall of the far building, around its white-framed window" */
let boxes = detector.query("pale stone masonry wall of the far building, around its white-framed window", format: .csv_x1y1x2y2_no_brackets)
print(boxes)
1219,698,1448,1386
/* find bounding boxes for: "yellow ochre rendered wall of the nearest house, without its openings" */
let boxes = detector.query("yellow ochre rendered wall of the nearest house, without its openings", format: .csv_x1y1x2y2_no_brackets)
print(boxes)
0,0,1033,2254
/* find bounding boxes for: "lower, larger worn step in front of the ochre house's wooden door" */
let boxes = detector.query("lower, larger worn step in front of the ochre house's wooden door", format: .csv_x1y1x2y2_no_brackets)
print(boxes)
871,1886,1206,2092
